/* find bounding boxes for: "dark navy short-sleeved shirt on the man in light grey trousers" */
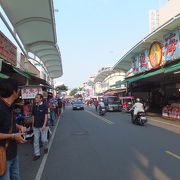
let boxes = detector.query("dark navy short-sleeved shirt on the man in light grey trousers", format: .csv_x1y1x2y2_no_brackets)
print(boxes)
32,103,48,128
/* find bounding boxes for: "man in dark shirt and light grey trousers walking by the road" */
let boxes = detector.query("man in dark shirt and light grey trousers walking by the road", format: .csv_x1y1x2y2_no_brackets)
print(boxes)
32,94,48,161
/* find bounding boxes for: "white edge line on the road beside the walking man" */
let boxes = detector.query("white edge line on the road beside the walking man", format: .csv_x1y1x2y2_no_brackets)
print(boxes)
35,117,60,180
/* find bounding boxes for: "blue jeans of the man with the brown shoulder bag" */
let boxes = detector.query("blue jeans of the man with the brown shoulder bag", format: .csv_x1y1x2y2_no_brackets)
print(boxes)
0,156,20,180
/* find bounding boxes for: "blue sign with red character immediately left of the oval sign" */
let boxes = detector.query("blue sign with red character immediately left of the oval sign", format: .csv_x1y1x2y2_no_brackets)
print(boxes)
132,49,148,74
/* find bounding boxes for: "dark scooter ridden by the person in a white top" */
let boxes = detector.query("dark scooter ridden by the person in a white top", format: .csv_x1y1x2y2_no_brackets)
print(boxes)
130,110,147,126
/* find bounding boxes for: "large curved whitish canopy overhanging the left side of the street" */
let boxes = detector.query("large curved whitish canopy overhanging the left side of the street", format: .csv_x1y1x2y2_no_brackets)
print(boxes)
0,0,63,78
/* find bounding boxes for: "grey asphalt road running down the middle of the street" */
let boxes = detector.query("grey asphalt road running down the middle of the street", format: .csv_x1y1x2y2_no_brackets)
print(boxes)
37,108,180,180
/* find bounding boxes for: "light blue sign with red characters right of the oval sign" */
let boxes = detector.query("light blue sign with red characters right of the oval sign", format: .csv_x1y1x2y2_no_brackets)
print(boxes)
163,29,180,61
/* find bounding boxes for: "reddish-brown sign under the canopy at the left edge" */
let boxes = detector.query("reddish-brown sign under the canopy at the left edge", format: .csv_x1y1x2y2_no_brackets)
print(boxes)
0,32,17,65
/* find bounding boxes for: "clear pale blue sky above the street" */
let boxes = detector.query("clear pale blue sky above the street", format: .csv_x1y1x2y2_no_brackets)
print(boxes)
54,0,167,88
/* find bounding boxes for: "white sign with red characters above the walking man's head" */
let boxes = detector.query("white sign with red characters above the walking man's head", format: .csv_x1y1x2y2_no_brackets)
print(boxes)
21,87,43,99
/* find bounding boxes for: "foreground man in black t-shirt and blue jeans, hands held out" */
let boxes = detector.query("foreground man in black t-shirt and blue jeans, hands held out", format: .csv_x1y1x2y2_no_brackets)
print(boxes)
0,78,26,180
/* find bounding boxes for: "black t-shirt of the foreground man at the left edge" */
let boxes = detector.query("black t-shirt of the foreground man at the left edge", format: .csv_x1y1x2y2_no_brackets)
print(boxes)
0,99,17,160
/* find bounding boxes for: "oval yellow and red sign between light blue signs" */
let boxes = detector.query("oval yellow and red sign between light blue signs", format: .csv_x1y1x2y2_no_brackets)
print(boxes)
149,42,162,69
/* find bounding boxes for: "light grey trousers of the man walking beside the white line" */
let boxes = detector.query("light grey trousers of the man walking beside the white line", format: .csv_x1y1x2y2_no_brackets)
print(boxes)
33,127,48,156
